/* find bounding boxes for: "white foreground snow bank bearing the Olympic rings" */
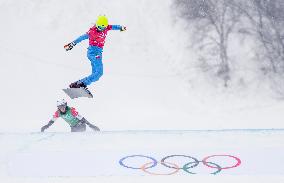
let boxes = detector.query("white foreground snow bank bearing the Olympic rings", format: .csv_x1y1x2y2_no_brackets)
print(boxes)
0,130,284,182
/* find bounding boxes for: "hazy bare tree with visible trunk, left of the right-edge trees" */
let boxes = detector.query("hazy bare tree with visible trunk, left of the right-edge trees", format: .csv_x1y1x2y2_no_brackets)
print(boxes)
175,0,240,87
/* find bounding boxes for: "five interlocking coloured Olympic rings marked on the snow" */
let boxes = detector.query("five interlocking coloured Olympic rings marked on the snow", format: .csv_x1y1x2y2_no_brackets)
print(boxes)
119,155,241,175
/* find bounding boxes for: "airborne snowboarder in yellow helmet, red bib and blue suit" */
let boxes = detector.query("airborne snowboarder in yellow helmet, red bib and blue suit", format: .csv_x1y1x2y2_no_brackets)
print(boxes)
64,16,126,94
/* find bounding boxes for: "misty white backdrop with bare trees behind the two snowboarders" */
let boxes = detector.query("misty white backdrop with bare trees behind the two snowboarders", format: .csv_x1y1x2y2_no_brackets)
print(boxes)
0,0,284,132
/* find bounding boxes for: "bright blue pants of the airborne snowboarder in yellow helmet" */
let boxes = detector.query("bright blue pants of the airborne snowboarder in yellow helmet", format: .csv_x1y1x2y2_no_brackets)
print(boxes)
80,46,103,86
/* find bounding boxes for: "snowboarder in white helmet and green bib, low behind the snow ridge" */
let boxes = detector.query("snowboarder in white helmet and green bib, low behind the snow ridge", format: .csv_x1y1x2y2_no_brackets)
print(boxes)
41,99,100,132
